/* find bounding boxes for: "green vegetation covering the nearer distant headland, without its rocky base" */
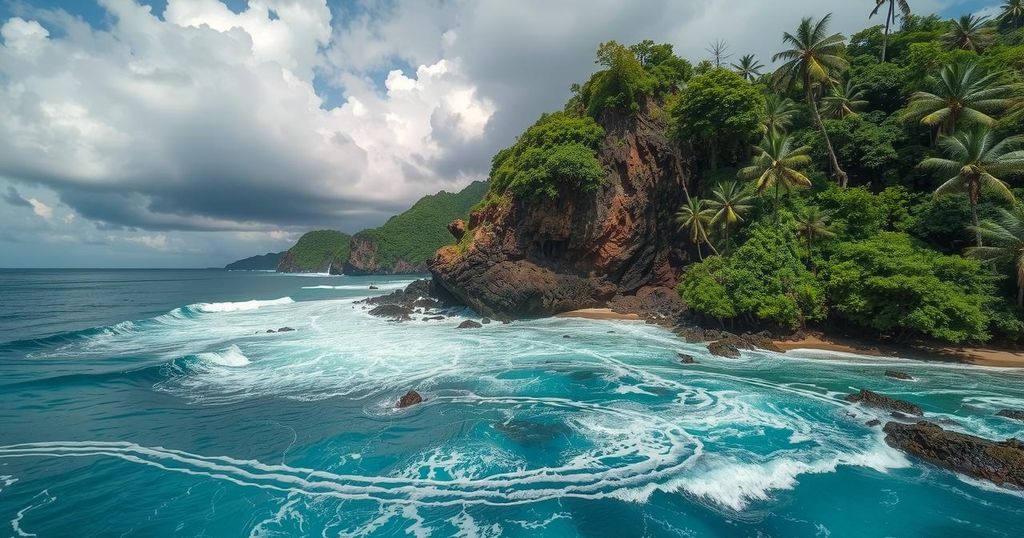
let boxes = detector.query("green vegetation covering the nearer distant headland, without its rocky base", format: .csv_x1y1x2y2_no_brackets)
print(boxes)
354,181,488,267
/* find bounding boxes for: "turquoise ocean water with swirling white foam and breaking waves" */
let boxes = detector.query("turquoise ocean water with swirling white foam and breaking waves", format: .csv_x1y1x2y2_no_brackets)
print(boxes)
0,271,1024,537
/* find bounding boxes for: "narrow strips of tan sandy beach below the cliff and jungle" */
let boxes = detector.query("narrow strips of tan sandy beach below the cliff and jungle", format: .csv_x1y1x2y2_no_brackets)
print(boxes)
556,308,1024,368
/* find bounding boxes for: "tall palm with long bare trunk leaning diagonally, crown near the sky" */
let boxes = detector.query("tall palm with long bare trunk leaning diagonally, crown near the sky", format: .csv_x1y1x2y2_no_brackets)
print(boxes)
772,13,850,187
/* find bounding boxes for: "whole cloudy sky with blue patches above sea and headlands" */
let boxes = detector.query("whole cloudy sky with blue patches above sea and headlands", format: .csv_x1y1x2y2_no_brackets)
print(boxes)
0,0,999,267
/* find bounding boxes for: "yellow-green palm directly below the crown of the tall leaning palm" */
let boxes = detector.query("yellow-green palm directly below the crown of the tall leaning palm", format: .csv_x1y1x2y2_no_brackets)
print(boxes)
737,133,811,217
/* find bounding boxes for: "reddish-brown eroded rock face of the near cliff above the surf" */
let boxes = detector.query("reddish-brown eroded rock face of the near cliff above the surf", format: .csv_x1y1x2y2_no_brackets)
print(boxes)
430,105,691,319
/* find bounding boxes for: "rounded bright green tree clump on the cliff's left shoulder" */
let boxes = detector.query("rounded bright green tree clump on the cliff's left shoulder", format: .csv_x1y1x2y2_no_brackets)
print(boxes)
490,112,604,200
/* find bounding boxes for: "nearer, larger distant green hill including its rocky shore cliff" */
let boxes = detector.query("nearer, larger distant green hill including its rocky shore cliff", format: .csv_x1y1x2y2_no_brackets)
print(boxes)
345,181,487,275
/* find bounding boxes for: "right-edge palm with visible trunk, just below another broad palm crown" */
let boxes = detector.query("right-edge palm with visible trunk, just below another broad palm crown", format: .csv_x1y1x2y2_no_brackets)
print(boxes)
920,125,1024,247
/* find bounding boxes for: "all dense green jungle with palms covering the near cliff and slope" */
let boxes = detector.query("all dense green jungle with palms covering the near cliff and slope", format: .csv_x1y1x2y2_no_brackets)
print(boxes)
471,12,1024,342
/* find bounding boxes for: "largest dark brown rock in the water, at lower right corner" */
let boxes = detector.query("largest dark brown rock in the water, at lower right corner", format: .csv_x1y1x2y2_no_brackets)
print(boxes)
883,421,1024,489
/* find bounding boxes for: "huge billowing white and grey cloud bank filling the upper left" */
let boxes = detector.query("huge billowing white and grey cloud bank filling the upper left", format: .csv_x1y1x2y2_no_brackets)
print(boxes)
0,0,494,231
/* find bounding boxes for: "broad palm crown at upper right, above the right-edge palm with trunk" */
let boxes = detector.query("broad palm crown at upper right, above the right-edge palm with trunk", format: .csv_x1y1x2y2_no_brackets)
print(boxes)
904,61,1014,134
